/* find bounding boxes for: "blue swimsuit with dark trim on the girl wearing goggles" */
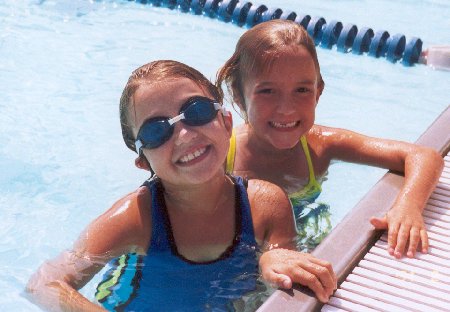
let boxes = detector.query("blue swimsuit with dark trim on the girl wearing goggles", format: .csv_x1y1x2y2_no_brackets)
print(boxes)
96,177,259,311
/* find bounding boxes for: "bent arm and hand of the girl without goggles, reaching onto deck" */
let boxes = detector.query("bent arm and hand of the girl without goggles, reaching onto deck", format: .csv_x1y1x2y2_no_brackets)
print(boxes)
314,127,443,258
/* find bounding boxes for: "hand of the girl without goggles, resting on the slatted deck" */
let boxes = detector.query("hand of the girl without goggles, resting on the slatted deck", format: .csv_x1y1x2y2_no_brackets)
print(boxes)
370,207,429,258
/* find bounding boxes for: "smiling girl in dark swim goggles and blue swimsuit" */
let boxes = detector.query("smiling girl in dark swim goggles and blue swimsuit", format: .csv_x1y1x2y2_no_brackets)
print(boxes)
28,61,336,311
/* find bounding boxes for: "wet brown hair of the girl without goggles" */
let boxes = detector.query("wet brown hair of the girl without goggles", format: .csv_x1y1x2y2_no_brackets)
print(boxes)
216,20,325,111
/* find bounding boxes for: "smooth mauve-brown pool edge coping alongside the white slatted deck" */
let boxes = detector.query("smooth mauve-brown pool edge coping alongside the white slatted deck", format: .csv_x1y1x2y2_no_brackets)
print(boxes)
257,106,450,312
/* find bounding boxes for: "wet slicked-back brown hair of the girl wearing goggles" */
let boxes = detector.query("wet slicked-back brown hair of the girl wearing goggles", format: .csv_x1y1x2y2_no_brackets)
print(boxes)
119,60,223,152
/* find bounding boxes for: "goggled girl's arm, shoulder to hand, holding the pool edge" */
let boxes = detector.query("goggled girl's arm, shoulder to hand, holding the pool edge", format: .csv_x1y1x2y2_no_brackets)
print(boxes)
248,180,337,302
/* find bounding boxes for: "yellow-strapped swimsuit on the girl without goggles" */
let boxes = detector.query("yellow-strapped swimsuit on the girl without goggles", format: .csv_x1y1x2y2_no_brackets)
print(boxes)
226,129,322,208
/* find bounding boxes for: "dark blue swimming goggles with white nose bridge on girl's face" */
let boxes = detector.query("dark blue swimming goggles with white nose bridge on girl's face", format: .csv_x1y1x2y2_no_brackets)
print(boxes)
135,96,228,154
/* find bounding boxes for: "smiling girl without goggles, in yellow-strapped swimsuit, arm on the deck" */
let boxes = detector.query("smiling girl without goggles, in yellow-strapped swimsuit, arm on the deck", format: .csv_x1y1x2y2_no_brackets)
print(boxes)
216,20,443,257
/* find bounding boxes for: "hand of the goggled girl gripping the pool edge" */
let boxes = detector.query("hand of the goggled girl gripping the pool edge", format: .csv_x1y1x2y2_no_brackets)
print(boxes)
259,249,337,302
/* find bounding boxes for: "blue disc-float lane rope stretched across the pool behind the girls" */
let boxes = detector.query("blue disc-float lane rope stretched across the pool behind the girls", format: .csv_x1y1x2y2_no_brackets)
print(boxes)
132,0,422,66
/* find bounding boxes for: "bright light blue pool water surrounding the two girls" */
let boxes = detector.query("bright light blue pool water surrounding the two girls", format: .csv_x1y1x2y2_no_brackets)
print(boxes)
0,0,450,311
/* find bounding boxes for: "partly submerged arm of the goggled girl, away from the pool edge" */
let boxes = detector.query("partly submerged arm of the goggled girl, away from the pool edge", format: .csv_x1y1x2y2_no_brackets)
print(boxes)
26,188,151,311
